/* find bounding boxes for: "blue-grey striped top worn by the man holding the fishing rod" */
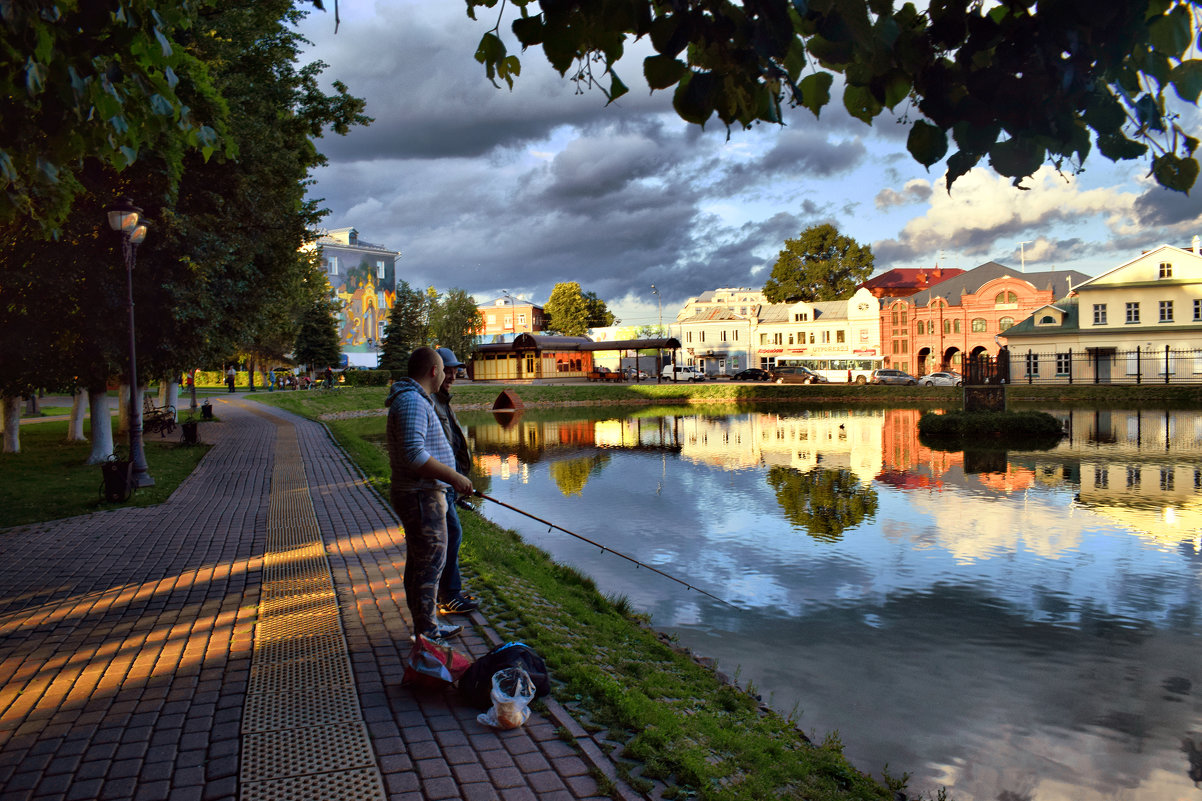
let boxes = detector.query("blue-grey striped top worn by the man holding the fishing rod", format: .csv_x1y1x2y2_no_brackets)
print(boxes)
387,378,454,490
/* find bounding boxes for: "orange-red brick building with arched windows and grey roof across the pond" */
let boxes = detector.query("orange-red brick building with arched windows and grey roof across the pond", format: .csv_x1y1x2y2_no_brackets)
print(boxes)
881,261,1090,375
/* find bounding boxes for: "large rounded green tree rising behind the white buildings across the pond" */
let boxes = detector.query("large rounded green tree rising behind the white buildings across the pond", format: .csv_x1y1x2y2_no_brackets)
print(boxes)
763,224,873,303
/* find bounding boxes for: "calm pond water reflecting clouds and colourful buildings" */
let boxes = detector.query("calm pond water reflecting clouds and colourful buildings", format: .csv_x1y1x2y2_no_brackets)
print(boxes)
464,409,1202,801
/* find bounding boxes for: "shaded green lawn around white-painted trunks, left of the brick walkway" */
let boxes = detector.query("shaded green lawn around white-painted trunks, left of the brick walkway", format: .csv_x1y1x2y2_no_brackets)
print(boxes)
0,421,209,528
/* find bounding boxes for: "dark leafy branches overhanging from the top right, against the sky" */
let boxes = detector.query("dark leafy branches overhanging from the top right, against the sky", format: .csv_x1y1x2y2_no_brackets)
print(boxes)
468,0,1202,191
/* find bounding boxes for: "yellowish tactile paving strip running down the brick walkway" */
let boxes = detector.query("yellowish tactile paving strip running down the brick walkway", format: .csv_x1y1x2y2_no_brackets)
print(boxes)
239,413,386,801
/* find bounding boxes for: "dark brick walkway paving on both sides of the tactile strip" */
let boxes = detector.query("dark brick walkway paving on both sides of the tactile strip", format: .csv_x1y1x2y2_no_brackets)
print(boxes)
0,398,638,801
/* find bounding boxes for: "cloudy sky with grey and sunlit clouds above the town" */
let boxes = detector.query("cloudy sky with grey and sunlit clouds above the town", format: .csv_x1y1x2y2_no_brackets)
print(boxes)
293,0,1202,325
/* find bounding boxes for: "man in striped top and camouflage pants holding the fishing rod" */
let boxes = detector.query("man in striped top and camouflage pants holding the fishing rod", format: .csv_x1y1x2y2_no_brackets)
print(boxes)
385,348,474,640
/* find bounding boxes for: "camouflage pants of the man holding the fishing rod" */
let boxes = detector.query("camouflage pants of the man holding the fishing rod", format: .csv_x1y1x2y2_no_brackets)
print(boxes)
392,490,447,634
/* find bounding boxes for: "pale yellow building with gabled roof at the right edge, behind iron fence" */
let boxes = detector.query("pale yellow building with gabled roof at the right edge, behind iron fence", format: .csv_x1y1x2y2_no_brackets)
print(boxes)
1002,237,1202,384
